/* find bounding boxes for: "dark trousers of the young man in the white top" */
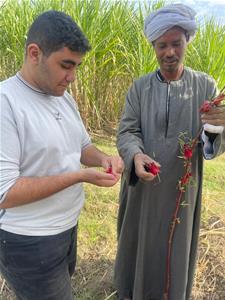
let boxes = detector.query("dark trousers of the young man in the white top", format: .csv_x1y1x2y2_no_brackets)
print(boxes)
0,227,77,300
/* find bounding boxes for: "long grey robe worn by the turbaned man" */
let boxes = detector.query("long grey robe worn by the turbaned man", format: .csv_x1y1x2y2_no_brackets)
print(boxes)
115,68,225,300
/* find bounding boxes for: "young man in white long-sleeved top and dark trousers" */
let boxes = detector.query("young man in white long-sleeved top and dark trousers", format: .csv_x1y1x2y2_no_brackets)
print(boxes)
0,11,123,300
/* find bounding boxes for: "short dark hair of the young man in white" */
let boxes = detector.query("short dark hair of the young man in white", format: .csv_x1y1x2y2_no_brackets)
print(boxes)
26,10,91,56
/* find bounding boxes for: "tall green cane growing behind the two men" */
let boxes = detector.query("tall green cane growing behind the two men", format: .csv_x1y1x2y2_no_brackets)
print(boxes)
0,0,225,129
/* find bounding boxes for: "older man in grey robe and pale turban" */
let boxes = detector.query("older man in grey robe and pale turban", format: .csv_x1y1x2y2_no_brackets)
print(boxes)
115,4,225,300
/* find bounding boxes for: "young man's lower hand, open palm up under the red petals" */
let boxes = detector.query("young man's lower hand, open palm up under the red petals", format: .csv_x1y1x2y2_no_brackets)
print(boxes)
79,168,120,187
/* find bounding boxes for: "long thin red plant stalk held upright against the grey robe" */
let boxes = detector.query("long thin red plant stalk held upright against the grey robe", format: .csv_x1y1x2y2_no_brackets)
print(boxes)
163,86,225,300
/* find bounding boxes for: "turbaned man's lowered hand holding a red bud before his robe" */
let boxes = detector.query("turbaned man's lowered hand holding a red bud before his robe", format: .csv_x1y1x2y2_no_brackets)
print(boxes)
134,153,160,181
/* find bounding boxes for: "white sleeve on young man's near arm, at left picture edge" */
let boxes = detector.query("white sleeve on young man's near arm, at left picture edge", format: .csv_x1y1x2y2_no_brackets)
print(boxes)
0,94,21,202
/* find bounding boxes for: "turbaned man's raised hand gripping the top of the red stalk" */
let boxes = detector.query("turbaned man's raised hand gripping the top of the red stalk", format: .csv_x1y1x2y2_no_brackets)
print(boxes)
201,105,225,127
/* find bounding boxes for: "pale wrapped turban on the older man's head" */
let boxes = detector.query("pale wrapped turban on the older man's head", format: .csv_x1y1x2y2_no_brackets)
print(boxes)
144,4,197,42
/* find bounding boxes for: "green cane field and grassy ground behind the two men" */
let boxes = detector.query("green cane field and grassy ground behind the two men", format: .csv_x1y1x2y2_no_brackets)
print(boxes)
0,0,225,300
